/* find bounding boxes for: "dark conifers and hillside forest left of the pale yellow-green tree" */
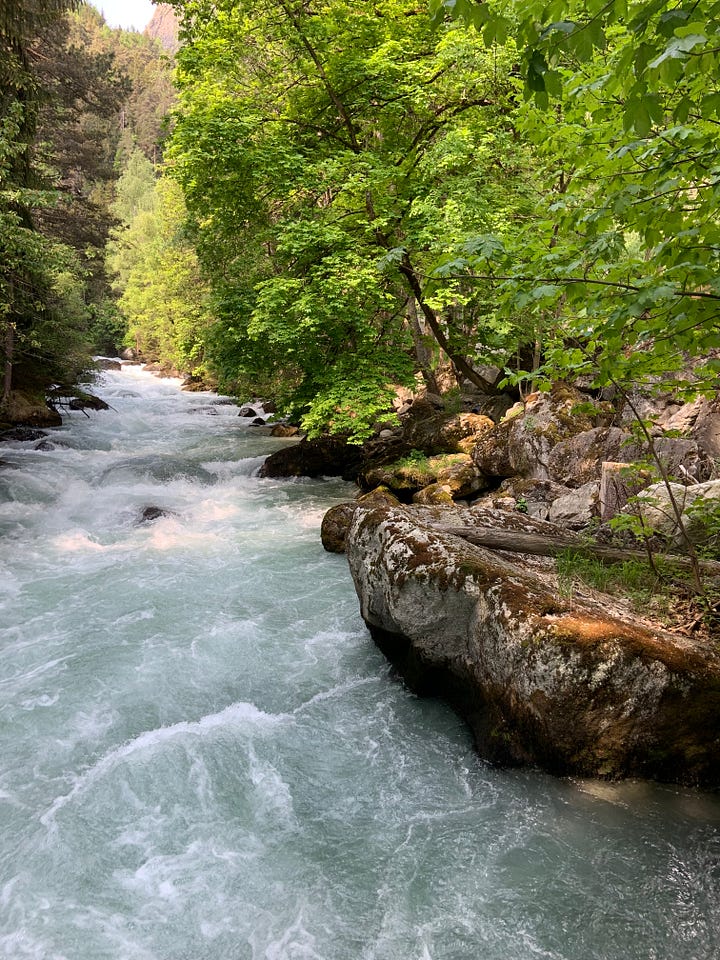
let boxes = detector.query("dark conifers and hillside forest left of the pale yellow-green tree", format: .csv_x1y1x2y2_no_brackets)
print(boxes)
0,0,174,406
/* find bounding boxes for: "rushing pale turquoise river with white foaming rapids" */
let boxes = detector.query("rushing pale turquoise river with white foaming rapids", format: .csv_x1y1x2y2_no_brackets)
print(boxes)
0,368,720,960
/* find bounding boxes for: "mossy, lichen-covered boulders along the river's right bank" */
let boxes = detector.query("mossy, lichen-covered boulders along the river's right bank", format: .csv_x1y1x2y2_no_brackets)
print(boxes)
286,386,720,789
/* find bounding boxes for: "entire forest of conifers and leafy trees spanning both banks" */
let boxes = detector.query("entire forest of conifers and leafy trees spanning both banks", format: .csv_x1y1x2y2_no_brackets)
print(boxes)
0,0,720,439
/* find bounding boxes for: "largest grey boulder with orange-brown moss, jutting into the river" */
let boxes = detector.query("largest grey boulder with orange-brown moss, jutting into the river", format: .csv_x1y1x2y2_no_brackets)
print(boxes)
346,505,720,788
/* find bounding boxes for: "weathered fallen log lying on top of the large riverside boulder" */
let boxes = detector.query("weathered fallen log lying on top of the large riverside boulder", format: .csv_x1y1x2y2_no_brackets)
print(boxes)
428,523,720,577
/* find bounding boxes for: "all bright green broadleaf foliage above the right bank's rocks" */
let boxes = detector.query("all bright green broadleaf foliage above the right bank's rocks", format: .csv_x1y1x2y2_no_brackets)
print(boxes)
156,0,720,438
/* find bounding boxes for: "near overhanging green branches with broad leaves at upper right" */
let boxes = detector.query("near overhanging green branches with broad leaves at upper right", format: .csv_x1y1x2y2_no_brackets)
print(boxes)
430,0,720,389
